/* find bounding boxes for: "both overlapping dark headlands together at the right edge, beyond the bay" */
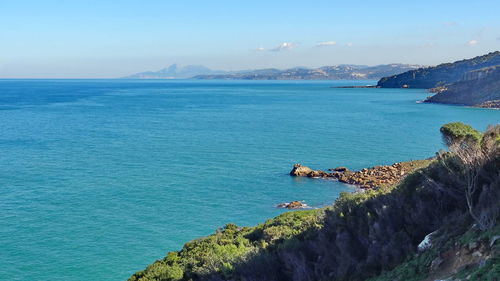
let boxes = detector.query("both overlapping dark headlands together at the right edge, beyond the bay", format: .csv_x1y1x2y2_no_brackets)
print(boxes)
377,51,500,108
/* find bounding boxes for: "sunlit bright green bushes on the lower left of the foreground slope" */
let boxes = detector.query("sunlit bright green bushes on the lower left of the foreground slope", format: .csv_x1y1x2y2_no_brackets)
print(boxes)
129,209,324,281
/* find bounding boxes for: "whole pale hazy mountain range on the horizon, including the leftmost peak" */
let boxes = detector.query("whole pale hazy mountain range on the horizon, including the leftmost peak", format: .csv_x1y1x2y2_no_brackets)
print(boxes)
124,64,422,80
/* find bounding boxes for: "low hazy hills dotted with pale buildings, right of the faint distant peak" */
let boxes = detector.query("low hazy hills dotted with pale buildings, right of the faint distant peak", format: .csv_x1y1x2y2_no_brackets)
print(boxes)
194,64,420,80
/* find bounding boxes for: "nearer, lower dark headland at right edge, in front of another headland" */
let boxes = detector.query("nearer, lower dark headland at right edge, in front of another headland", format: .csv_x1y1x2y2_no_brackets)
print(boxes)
426,66,500,107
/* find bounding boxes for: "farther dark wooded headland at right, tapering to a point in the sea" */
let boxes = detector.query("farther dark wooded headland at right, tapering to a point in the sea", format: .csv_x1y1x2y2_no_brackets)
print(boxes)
377,51,500,89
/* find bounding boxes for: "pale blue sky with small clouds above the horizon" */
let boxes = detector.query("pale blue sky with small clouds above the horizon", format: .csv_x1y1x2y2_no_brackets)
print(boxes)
0,0,500,78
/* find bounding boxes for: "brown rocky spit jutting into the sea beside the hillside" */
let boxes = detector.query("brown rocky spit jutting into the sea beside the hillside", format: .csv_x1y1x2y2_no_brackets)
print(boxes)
290,162,414,188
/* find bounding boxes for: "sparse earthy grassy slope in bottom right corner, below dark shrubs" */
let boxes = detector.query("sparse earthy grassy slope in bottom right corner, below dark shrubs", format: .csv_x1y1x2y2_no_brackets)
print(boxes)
369,226,500,281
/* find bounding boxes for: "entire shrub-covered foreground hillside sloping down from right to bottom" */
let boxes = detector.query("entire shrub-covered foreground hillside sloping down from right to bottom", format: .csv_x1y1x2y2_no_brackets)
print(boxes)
129,123,500,281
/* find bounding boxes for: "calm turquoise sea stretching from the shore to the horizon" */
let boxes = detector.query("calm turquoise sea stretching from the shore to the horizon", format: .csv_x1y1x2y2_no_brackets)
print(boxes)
0,80,500,281
